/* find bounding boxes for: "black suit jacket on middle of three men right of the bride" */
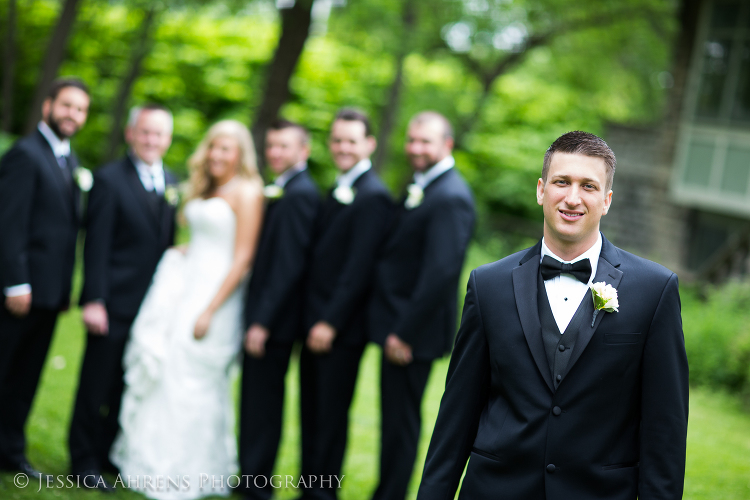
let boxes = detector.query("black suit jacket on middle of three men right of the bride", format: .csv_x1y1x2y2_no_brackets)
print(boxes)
306,169,393,345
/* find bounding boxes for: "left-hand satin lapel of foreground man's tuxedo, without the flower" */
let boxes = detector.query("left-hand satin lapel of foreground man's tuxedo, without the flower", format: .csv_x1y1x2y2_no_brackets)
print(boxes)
512,242,554,392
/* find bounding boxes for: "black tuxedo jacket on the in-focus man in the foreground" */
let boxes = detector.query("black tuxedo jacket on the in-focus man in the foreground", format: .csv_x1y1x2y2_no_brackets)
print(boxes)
418,239,688,500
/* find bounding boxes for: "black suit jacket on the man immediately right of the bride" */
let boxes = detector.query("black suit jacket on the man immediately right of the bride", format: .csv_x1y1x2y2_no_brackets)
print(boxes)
245,170,320,343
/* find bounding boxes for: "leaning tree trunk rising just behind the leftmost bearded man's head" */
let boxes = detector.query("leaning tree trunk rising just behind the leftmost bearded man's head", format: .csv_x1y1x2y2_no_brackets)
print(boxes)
24,0,79,133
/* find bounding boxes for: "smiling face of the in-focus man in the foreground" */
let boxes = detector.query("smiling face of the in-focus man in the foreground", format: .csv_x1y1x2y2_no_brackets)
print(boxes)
536,152,612,260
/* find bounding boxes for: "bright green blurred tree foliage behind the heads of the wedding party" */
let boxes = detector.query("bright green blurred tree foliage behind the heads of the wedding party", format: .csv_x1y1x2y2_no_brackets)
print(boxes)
0,0,676,225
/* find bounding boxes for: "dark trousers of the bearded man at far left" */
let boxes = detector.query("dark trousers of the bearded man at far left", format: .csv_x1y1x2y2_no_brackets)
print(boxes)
0,306,58,468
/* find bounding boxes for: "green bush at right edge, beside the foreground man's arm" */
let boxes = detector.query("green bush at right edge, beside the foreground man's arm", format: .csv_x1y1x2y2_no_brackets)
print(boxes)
682,282,750,400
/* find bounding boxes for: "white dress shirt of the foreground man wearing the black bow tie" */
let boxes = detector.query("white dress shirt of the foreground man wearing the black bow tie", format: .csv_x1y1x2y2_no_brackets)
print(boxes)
539,233,602,333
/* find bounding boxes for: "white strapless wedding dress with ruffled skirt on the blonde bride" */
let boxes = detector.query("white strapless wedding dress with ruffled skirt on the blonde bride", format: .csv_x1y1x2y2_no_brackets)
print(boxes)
111,198,244,500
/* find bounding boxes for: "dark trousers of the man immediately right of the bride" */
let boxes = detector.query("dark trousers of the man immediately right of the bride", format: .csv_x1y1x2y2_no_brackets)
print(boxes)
238,342,292,500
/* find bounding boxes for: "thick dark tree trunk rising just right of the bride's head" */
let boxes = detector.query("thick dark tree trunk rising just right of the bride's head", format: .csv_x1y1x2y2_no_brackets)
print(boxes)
252,0,313,166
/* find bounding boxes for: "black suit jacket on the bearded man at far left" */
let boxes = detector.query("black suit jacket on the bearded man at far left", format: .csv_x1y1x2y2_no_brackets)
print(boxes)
0,130,80,309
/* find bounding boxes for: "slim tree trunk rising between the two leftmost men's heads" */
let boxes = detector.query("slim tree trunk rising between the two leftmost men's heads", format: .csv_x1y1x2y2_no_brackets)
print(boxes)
105,4,156,161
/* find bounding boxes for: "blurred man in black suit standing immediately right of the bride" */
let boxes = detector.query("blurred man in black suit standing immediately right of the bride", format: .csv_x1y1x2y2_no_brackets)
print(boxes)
239,120,320,499
